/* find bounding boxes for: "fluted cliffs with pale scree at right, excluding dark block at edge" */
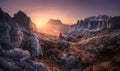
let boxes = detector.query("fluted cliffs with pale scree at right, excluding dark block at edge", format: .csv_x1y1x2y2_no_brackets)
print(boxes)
69,15,111,35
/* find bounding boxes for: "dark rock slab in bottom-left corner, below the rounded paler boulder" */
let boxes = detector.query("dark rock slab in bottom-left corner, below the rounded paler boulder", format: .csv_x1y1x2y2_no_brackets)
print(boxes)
0,54,49,71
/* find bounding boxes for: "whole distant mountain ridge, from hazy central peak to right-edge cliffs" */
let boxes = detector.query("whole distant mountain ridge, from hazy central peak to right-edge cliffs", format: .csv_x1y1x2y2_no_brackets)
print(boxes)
42,15,120,35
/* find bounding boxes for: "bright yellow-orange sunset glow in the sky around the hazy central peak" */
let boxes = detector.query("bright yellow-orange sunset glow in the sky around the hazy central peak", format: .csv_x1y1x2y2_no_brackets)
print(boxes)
29,9,77,27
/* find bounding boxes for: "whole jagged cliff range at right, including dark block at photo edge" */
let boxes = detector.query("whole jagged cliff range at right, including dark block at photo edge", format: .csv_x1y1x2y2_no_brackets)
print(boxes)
68,15,120,36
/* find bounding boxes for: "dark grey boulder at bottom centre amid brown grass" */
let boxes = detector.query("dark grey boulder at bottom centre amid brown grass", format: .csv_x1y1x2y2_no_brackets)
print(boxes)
59,55,82,71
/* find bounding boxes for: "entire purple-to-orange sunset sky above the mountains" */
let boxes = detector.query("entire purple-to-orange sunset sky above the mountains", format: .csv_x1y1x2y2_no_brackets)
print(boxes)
0,0,120,25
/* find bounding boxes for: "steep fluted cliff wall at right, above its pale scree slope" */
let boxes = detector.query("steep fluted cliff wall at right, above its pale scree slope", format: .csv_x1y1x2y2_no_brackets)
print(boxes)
71,15,110,31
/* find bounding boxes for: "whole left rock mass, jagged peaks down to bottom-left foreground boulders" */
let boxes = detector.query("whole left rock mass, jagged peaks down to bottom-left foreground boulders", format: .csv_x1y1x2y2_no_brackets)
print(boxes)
0,8,48,71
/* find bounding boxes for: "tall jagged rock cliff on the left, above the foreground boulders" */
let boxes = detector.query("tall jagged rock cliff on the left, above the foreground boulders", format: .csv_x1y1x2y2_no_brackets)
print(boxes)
0,10,43,56
